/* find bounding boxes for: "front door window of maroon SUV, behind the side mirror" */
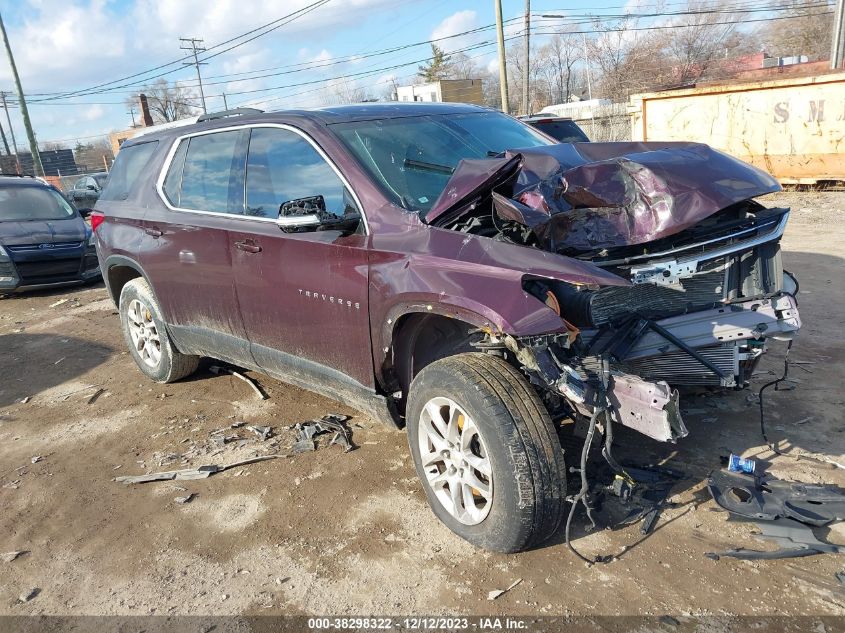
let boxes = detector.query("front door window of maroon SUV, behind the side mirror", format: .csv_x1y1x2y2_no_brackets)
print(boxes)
246,128,354,218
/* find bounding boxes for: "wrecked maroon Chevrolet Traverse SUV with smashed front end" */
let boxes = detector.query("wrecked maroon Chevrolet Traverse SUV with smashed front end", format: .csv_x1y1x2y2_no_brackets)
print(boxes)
93,104,800,551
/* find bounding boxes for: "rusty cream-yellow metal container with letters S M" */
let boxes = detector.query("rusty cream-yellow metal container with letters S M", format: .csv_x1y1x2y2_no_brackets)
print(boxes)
630,72,845,184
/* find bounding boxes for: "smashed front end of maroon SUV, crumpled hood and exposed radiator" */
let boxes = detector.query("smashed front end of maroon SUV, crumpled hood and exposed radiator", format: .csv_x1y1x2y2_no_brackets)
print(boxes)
436,143,801,441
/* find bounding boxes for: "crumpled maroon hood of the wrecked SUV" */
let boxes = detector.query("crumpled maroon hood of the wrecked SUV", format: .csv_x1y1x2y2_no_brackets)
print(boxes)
424,142,780,252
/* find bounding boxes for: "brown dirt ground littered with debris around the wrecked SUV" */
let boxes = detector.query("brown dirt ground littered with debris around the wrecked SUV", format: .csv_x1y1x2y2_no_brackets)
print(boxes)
0,193,845,615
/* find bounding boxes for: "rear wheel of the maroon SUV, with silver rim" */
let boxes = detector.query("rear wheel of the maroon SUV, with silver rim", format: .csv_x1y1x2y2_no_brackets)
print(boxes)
118,277,199,383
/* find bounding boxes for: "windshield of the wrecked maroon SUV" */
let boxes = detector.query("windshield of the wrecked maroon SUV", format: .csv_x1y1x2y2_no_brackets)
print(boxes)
332,112,552,211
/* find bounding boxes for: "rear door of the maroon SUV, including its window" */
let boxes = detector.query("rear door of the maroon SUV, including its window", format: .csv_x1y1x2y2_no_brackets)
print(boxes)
139,129,253,366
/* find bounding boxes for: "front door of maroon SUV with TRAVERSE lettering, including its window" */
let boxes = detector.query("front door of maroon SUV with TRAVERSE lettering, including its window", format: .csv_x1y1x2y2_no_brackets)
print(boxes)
231,127,374,388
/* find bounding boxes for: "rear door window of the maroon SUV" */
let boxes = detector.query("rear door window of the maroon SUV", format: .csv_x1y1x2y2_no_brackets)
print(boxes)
171,130,248,214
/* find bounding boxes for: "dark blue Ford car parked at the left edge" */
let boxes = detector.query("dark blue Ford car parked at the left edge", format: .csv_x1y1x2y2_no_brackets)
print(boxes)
0,176,100,292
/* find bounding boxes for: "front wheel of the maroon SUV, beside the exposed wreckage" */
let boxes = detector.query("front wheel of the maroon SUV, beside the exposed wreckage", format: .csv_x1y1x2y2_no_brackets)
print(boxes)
406,353,566,552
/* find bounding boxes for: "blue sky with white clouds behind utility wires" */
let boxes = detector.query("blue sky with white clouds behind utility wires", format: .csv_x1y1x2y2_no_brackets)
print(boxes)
0,0,631,151
